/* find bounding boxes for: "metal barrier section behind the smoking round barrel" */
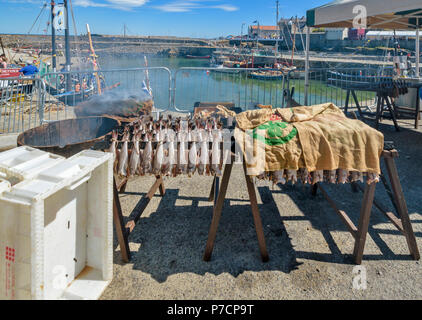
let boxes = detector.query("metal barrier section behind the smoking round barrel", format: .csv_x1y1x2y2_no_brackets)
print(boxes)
42,67,172,121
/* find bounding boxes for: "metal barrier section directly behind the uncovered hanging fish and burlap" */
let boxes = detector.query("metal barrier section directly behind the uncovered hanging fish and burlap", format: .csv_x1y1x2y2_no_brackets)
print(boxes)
172,67,286,112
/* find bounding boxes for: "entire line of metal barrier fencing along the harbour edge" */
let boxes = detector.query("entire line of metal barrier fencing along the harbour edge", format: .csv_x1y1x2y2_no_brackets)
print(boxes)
0,67,393,133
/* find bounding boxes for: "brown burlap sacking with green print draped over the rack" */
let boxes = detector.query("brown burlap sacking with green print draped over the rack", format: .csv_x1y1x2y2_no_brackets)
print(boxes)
235,103,384,175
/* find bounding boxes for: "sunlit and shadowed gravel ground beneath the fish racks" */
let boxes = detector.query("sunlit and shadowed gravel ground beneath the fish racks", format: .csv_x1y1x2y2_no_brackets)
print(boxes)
101,117,422,299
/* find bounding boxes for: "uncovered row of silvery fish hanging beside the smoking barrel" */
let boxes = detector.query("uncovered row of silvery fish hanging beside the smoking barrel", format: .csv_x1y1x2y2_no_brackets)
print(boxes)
109,115,227,177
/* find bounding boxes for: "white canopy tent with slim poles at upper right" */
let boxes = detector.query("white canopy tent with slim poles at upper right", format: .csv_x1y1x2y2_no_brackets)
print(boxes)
305,0,422,104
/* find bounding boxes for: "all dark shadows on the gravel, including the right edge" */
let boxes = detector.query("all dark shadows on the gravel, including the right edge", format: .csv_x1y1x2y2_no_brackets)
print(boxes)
115,118,422,282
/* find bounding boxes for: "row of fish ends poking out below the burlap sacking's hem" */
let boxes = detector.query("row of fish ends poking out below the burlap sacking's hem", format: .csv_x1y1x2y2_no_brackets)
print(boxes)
257,168,380,184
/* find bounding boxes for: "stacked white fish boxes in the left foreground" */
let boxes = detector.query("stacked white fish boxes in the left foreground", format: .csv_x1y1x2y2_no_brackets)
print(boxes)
0,147,113,299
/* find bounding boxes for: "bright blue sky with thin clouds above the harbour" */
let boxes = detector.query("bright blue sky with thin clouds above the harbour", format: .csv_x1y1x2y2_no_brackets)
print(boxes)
0,0,330,37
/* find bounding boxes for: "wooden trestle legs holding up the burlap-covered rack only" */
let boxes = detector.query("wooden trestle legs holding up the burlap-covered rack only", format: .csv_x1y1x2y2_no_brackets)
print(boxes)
204,150,420,264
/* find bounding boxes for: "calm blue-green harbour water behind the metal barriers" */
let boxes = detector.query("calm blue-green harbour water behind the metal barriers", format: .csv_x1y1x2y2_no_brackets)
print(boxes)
100,55,373,111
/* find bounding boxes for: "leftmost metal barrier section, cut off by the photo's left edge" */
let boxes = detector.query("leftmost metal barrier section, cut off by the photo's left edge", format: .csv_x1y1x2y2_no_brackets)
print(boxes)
0,78,45,133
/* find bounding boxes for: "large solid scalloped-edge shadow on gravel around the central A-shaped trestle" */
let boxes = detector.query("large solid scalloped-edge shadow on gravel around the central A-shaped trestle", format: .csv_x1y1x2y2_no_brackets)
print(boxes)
117,189,298,282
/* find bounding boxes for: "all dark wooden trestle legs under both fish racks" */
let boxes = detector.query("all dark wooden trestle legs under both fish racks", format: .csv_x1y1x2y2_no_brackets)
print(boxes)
113,150,420,264
